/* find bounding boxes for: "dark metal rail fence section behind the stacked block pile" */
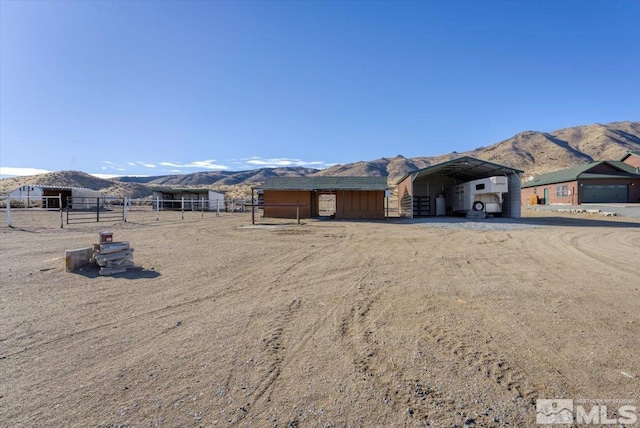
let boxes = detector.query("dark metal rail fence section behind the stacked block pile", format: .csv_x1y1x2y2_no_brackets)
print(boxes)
65,196,128,224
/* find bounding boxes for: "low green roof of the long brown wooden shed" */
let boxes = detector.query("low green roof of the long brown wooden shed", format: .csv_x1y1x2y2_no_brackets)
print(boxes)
254,176,389,191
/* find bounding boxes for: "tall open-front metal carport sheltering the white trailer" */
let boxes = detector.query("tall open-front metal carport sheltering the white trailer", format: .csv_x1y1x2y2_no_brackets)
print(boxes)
398,156,522,218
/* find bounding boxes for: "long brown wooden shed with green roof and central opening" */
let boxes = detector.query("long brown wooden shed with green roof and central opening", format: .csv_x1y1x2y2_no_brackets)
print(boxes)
252,176,389,219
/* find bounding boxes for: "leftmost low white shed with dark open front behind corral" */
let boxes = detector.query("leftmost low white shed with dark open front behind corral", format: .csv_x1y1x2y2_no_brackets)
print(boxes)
9,185,106,209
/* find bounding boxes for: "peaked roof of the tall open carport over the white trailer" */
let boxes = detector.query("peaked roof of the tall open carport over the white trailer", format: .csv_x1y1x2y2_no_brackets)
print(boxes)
398,156,524,183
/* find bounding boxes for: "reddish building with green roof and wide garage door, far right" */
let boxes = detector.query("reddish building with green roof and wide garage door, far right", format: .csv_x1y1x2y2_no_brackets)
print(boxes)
522,162,640,205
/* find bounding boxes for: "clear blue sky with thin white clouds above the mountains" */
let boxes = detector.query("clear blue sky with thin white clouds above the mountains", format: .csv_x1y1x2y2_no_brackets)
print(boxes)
0,0,640,175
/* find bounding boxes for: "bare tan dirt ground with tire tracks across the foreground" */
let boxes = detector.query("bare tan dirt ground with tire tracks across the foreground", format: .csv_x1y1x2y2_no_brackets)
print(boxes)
0,212,640,427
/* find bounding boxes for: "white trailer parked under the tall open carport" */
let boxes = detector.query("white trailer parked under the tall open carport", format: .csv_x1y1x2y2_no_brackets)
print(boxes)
447,176,509,214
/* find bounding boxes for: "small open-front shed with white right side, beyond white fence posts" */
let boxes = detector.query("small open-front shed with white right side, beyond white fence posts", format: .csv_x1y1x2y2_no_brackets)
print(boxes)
153,187,225,211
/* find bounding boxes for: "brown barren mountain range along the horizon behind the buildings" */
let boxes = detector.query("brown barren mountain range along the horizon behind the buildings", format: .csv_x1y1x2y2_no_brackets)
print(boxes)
0,121,640,197
